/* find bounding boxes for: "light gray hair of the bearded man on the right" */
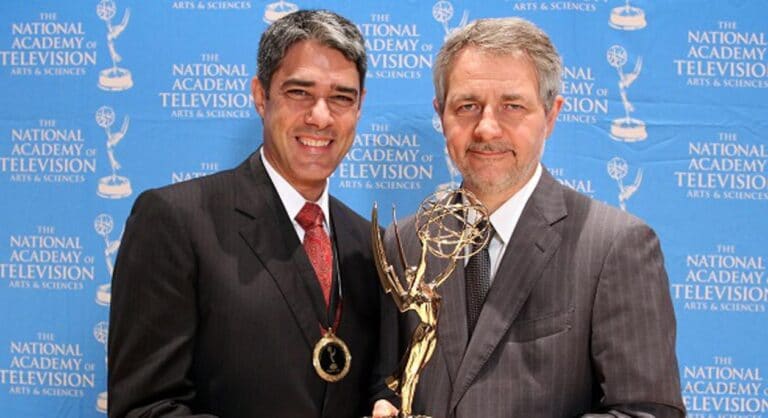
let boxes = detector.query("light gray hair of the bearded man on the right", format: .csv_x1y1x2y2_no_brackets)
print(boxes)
433,17,563,113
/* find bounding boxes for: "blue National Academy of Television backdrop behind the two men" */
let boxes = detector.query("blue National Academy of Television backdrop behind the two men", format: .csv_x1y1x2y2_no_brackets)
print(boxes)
0,0,768,418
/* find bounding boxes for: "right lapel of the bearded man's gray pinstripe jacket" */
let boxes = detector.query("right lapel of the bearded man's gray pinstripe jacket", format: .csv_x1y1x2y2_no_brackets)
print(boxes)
450,170,566,410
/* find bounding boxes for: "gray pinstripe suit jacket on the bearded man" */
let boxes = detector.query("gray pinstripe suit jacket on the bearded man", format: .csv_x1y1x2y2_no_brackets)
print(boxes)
384,170,684,418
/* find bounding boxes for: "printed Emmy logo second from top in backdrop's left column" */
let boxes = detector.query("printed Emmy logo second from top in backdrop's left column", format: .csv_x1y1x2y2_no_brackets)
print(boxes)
96,106,133,199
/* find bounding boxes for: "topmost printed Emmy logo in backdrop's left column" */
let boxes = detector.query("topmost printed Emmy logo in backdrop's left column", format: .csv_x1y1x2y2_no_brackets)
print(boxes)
96,0,133,91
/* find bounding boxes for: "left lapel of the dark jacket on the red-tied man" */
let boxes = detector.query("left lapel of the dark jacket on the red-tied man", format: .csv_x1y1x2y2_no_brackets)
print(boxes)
235,152,325,348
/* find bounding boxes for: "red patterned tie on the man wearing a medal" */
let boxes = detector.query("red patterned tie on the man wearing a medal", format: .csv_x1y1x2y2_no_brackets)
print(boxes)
296,202,333,306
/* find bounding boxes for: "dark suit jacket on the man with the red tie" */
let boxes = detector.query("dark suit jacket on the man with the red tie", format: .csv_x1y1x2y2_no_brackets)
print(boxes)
109,153,380,418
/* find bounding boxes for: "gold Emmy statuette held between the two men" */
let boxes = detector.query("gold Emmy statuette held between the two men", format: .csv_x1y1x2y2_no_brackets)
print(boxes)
371,189,489,418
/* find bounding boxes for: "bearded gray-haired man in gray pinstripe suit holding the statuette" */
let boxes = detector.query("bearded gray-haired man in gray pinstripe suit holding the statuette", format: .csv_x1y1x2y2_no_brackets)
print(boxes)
374,18,684,418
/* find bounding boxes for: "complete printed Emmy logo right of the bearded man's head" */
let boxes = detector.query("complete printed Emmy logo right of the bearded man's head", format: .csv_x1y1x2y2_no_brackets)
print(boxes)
606,45,648,142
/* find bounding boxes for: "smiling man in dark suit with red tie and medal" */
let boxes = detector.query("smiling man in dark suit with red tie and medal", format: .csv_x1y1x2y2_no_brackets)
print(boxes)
108,10,380,418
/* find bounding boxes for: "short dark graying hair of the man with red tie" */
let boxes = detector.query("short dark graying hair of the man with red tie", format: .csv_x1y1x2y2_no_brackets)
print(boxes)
256,10,368,95
